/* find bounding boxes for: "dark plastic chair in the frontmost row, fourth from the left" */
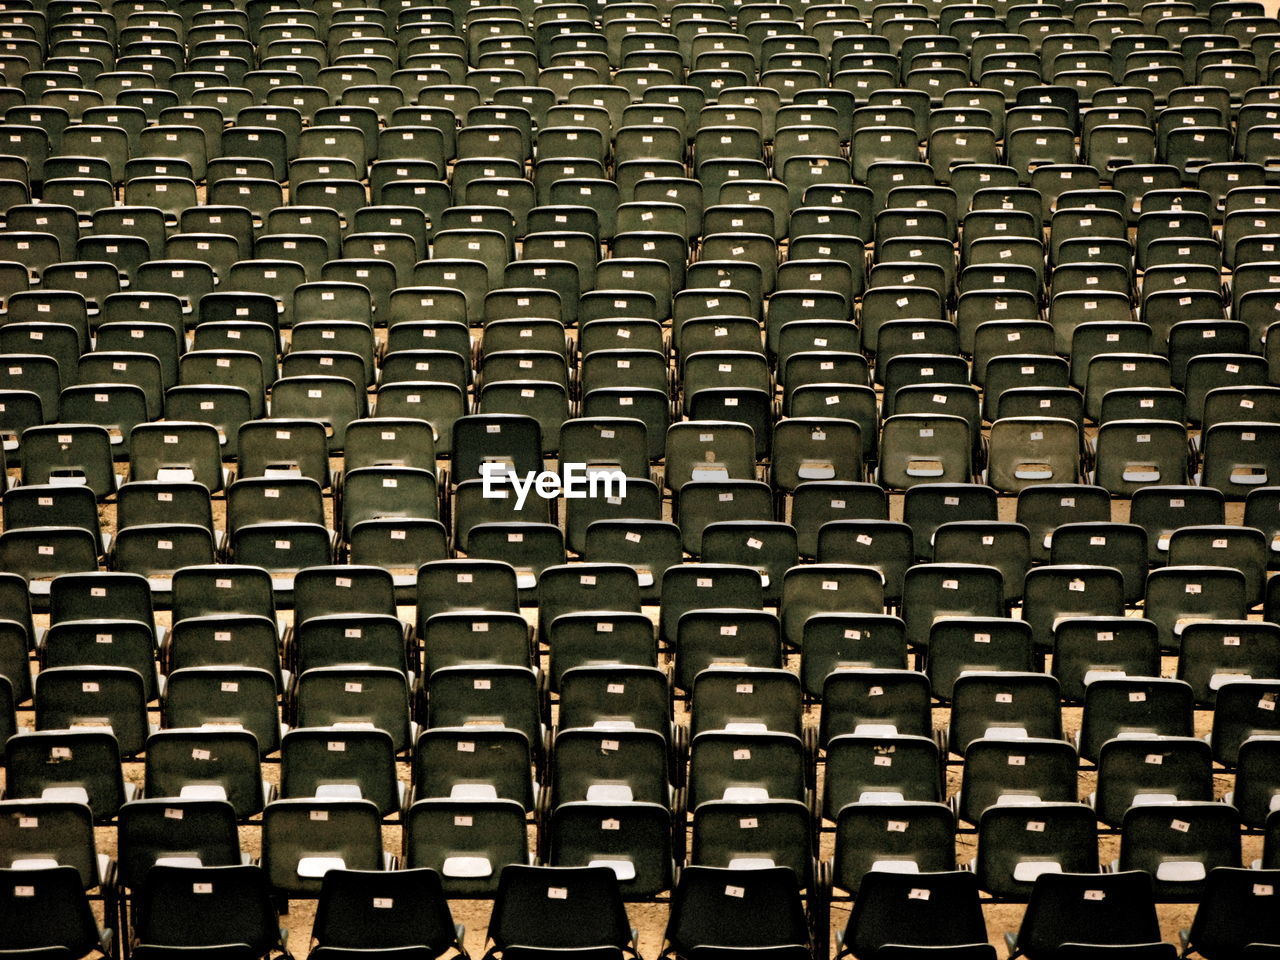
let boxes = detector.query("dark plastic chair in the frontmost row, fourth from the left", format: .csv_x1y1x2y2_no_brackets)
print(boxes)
485,864,636,957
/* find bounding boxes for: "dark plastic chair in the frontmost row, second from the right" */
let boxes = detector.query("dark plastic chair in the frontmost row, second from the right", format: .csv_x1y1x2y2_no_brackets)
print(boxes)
1005,870,1160,960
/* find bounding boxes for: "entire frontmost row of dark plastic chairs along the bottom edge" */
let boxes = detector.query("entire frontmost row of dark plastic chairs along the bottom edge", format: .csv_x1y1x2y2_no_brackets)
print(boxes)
0,865,1276,960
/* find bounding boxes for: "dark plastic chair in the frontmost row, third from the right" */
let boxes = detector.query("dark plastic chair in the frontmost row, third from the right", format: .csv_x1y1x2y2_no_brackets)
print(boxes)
836,870,987,959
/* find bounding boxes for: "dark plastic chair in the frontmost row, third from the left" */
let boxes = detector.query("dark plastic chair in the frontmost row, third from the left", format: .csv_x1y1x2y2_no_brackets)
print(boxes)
311,868,466,957
